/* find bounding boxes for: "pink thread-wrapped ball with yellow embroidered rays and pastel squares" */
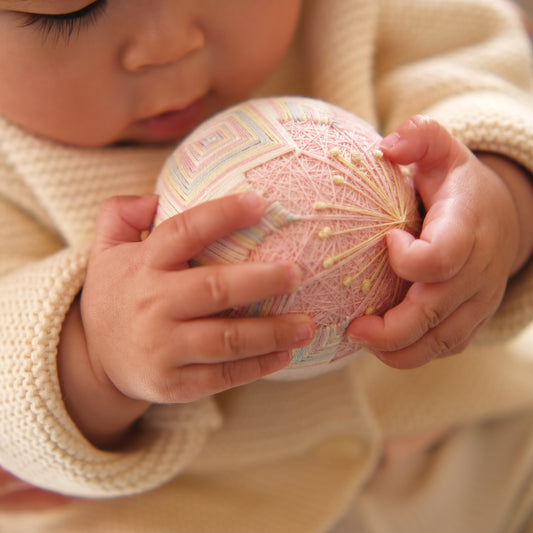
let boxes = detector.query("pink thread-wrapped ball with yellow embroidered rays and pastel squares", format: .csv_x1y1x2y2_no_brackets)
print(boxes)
155,97,420,378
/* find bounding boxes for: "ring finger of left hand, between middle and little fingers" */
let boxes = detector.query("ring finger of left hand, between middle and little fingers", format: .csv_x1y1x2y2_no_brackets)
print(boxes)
167,313,315,367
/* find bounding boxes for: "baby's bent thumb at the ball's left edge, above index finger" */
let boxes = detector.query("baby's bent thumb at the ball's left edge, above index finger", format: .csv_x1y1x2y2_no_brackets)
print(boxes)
93,194,158,251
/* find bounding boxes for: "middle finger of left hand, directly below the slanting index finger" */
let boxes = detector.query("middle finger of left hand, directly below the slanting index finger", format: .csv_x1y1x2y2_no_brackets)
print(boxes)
165,262,301,320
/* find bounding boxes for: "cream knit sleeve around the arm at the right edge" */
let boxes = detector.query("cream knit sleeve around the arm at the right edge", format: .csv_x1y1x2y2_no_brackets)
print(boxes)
376,0,533,341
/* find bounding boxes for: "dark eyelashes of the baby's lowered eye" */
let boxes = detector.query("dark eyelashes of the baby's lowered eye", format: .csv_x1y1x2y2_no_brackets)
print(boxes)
17,0,107,42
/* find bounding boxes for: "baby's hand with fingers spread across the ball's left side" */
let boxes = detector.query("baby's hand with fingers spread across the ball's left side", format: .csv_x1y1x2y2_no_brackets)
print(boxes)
81,193,314,403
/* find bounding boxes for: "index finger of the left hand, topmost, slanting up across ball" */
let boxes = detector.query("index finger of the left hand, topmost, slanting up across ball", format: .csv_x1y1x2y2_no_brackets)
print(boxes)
145,191,266,270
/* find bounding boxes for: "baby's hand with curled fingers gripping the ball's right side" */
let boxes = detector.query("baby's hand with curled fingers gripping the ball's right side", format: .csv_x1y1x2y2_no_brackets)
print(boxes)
347,116,533,368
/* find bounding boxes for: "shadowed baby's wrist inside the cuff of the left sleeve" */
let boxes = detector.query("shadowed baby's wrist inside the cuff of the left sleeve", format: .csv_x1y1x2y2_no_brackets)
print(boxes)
57,298,150,449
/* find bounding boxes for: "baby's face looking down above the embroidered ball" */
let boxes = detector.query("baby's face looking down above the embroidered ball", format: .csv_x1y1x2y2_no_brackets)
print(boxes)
0,0,301,146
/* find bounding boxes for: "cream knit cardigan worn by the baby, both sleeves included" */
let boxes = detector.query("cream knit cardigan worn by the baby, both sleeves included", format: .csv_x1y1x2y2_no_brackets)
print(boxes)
0,0,533,533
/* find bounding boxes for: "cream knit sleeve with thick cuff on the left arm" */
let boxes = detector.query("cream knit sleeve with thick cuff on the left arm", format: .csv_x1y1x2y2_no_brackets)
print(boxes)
0,164,219,498
